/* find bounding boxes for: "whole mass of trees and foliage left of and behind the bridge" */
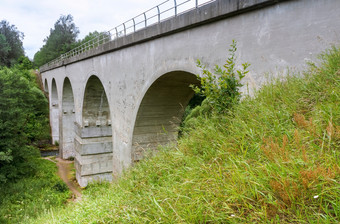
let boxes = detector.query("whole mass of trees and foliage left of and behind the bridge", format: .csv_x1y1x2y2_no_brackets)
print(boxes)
0,15,105,184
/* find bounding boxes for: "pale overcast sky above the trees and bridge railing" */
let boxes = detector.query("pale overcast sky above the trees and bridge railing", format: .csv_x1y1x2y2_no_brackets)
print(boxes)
0,0,206,59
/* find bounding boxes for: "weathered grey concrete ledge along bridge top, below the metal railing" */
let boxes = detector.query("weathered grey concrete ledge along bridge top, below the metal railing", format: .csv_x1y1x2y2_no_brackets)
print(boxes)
40,0,287,72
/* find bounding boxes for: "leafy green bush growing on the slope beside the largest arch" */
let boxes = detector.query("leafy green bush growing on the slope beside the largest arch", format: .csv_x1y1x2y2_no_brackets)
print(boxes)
181,40,250,130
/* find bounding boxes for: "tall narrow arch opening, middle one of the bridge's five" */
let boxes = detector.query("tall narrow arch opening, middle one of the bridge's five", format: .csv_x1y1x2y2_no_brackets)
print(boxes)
59,77,75,159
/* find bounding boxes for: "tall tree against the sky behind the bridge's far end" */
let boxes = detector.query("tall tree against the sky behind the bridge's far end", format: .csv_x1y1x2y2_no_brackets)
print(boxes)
33,15,79,67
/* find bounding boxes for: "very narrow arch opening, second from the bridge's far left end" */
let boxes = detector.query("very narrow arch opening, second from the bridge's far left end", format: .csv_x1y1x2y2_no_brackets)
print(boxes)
50,78,59,144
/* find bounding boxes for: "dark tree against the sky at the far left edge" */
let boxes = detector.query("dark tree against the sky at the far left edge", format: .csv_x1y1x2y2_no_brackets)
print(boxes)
0,20,25,67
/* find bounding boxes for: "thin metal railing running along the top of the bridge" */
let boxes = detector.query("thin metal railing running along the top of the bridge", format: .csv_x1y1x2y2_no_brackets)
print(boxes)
43,0,216,67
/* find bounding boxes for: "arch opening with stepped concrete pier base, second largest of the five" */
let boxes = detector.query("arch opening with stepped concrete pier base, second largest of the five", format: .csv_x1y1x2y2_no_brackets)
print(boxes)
75,75,113,187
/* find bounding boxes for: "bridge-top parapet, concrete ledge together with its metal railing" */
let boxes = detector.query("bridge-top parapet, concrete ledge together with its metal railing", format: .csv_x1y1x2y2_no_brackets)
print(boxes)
40,0,287,72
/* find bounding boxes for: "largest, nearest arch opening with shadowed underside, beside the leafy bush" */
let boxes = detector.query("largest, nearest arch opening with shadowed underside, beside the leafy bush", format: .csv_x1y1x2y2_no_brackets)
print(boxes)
131,71,199,162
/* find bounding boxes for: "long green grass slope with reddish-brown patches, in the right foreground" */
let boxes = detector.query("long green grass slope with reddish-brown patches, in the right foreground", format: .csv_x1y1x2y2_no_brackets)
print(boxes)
29,48,340,224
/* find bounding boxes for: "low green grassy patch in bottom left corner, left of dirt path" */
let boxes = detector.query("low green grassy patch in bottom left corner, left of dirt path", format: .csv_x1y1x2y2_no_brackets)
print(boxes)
0,159,70,223
